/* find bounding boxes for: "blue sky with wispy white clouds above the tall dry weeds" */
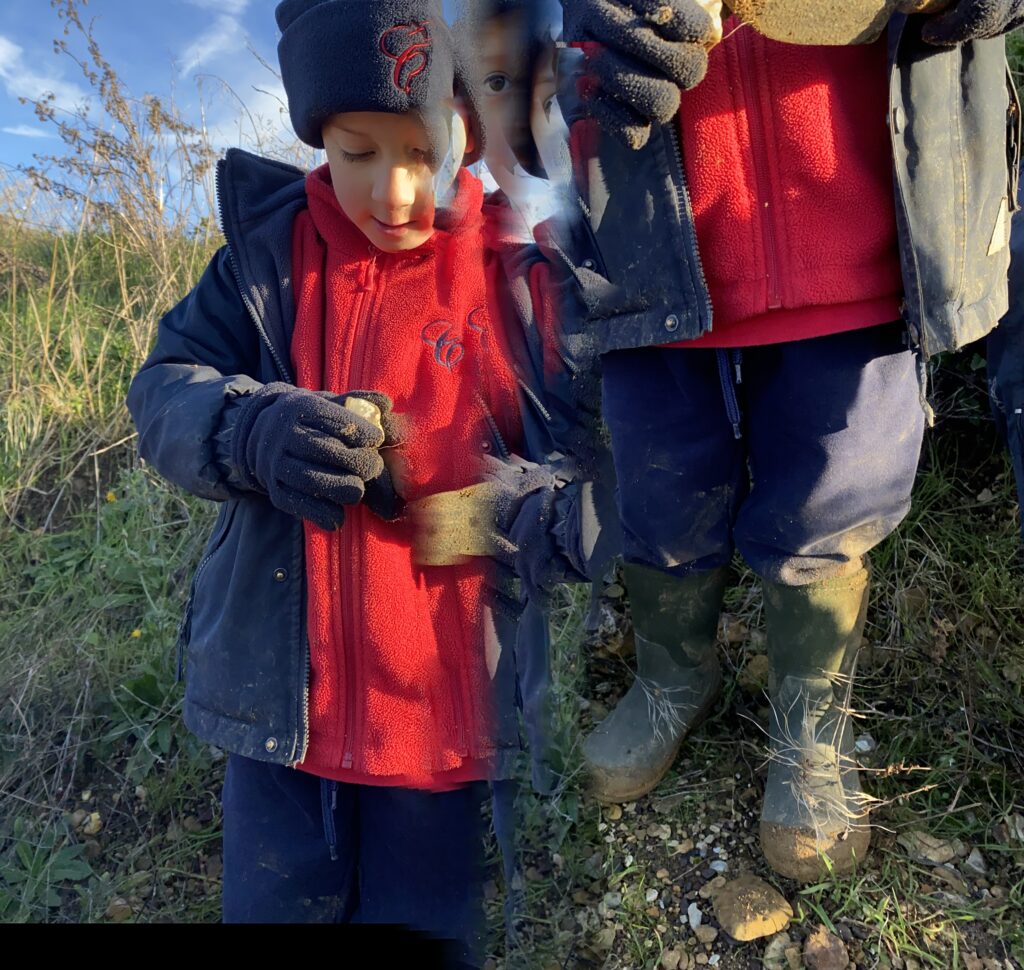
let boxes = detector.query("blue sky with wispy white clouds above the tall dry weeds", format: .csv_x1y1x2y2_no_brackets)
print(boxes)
0,0,460,168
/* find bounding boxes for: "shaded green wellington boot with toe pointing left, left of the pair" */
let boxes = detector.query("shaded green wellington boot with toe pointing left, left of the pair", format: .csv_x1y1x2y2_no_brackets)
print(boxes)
583,563,728,802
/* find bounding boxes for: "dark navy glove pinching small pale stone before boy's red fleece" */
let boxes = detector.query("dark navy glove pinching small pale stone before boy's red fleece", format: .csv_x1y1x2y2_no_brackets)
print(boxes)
231,382,390,531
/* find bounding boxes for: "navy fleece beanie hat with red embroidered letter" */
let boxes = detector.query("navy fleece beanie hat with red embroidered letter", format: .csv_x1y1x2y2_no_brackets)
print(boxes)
276,0,483,165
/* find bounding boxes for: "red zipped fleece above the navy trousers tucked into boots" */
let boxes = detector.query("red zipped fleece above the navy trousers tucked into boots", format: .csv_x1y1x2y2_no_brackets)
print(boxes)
659,17,902,347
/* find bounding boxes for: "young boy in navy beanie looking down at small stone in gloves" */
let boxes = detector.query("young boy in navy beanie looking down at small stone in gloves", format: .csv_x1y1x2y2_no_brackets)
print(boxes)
129,0,610,946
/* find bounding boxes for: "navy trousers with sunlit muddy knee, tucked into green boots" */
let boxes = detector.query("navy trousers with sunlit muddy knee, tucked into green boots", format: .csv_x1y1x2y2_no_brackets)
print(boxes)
603,323,925,586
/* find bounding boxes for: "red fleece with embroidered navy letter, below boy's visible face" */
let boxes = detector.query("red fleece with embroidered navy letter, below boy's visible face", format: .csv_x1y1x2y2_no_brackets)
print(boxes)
292,165,518,790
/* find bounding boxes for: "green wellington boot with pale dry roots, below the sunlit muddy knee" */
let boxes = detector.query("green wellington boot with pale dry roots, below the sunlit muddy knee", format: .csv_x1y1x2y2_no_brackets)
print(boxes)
761,568,871,882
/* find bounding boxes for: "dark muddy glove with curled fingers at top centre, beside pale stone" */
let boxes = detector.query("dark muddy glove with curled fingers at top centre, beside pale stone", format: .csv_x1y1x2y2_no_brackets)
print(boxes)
562,0,722,149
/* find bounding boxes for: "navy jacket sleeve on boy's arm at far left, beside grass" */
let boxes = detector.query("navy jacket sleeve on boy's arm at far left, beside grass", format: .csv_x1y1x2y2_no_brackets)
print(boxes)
128,247,262,502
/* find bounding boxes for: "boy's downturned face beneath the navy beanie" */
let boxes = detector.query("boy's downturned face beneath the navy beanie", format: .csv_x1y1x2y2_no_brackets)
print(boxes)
323,112,434,253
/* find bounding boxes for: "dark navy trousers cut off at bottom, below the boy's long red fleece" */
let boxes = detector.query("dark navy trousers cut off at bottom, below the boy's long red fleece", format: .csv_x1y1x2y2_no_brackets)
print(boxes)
223,755,487,966
